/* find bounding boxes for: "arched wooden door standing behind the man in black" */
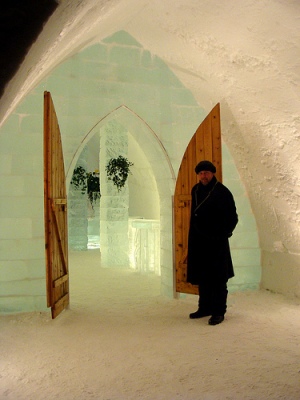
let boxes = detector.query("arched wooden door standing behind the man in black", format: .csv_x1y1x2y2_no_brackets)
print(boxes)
174,103,222,294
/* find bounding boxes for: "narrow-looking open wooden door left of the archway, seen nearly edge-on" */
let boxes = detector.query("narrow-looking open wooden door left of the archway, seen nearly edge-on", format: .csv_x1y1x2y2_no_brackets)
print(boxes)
44,92,69,318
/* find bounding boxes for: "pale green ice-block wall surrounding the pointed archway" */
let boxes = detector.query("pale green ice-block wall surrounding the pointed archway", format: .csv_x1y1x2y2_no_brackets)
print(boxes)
0,32,260,311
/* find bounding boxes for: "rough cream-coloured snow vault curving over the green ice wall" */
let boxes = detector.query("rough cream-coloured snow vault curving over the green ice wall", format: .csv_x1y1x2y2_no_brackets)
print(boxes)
0,0,300,295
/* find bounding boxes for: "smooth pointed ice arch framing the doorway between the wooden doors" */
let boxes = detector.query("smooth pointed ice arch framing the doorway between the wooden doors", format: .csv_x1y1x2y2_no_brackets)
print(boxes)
67,105,175,295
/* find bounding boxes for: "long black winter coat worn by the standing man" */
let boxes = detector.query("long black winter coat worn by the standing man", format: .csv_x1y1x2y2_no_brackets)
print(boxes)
187,177,238,285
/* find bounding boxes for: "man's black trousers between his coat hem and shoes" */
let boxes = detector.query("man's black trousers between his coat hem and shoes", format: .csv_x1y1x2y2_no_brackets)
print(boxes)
199,278,228,315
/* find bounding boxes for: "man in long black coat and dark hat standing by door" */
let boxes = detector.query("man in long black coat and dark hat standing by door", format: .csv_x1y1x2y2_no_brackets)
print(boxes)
187,161,238,325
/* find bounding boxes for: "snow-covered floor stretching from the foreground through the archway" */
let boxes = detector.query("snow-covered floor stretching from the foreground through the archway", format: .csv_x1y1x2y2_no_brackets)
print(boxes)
0,250,300,400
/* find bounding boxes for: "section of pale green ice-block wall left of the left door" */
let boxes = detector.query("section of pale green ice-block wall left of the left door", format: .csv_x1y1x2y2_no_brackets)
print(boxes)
0,112,46,313
